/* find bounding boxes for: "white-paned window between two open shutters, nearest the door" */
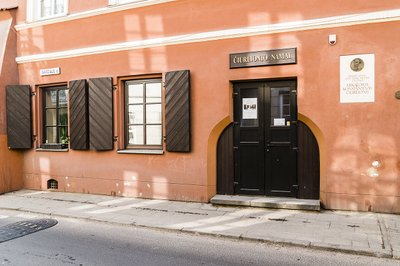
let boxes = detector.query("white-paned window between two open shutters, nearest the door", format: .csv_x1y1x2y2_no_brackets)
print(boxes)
125,79,162,149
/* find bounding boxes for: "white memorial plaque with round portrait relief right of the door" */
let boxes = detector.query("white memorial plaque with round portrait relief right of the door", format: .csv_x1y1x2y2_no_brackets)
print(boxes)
340,54,375,103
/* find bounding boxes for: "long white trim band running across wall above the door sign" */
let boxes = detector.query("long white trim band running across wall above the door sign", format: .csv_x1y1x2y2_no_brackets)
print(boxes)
16,9,400,64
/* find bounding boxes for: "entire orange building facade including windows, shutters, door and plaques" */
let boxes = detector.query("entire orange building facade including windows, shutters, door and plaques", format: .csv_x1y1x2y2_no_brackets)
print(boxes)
0,0,400,213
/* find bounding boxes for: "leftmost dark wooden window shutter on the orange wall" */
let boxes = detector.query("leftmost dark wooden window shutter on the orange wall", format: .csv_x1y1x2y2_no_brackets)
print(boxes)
6,85,32,149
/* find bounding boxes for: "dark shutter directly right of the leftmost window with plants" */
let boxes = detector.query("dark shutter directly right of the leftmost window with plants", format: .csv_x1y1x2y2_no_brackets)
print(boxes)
69,79,89,150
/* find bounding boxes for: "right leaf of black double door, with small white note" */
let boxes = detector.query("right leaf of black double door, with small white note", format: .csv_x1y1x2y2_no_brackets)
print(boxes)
265,81,297,197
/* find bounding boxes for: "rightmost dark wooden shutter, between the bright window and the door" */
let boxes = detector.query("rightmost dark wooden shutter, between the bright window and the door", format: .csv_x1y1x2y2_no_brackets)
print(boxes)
165,70,191,152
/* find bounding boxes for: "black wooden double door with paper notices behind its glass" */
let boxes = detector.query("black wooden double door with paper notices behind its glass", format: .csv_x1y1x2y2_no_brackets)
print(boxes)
234,80,297,197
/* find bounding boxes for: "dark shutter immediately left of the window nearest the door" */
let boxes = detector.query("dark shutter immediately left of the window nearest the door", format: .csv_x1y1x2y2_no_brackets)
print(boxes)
89,78,114,151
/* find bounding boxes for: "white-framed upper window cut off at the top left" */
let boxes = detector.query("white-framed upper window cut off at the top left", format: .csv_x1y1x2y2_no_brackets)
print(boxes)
28,0,68,21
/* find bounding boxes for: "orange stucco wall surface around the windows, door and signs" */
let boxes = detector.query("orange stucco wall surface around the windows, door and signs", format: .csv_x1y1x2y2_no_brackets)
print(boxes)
10,0,400,213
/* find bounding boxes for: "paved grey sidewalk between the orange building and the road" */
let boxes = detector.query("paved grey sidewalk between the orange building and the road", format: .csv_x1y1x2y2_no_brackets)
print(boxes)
0,190,400,259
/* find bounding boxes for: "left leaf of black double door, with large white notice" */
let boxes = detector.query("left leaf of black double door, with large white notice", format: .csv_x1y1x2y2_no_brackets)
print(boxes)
234,82,265,195
